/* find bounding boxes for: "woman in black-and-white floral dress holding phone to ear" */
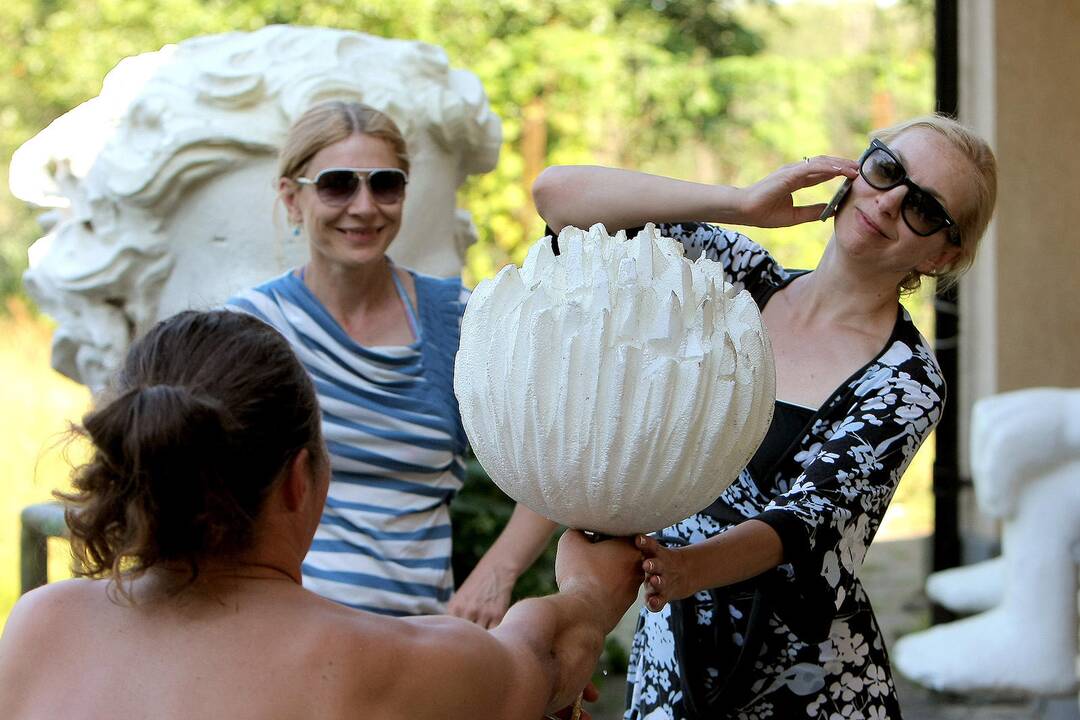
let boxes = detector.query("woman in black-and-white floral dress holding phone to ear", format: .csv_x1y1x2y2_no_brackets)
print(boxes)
534,116,996,720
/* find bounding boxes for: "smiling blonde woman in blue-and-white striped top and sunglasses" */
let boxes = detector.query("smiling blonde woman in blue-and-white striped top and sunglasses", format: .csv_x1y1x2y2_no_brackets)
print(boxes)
228,101,555,627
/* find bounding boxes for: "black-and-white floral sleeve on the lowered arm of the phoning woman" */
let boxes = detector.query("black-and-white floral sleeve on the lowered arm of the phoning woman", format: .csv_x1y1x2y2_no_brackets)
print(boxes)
758,354,945,637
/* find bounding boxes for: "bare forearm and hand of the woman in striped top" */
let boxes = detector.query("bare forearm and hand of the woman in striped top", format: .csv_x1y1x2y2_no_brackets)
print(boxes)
447,505,558,628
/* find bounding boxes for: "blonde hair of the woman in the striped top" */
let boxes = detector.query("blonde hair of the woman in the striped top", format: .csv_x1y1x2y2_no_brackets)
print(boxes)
278,100,408,179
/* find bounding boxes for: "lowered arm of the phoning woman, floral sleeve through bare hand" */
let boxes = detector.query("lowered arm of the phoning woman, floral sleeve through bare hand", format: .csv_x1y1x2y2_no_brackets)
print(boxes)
638,345,944,623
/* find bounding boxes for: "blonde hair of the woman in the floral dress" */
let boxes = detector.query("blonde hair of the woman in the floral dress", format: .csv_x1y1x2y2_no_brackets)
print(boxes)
870,113,998,293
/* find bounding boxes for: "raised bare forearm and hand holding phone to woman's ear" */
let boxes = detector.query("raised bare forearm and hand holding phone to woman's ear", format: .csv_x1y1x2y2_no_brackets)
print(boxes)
532,155,859,232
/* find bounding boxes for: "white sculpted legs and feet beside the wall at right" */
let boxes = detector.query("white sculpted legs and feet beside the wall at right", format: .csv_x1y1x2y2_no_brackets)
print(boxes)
893,388,1080,695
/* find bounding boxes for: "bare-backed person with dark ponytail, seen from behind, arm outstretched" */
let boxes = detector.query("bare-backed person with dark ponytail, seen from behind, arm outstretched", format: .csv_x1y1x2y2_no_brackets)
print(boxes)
0,311,642,720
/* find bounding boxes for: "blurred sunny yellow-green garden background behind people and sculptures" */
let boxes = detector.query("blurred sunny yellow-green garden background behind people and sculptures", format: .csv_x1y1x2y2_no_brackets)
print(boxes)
0,0,933,626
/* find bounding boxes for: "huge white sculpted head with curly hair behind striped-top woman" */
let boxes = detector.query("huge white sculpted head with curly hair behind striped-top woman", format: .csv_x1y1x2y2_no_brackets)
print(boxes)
11,26,501,388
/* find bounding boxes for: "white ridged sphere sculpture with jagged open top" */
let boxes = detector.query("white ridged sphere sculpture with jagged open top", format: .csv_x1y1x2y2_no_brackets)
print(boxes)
454,225,775,535
